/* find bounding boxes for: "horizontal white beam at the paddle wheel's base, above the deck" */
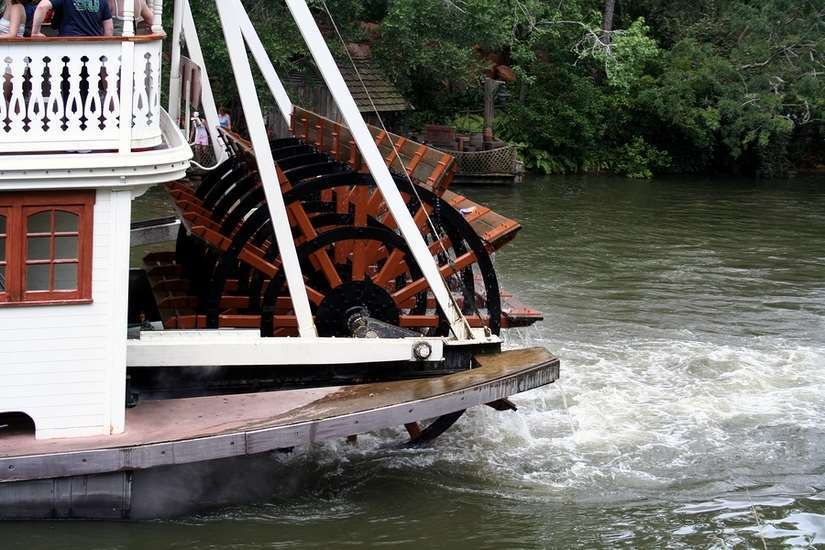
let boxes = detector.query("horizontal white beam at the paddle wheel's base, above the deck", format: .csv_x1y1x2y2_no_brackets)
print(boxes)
126,330,444,367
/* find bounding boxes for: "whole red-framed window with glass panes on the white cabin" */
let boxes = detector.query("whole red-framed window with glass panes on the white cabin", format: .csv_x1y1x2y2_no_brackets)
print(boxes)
0,191,95,306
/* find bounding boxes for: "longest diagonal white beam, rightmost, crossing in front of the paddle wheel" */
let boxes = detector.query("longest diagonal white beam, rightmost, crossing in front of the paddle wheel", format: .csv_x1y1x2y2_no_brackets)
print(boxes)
284,0,473,339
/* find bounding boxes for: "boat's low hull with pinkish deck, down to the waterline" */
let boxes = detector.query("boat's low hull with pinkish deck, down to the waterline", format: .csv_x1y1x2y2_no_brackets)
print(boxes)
0,348,559,519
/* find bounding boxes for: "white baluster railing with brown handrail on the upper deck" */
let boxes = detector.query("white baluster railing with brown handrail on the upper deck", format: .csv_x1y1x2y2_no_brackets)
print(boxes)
0,34,163,153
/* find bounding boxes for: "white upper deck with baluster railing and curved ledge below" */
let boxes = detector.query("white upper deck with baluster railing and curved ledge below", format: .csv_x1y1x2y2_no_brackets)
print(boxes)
0,11,191,189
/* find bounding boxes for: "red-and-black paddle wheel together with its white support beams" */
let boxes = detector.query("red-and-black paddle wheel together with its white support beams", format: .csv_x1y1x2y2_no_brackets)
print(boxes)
117,0,552,442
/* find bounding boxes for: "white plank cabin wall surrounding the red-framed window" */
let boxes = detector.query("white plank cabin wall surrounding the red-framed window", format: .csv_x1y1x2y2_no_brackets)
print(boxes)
0,189,132,439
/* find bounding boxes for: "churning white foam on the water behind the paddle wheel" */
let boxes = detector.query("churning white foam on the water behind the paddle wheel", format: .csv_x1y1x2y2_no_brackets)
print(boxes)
292,334,825,506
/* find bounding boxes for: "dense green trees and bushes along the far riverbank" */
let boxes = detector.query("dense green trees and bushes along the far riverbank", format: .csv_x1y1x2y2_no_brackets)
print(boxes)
193,0,825,177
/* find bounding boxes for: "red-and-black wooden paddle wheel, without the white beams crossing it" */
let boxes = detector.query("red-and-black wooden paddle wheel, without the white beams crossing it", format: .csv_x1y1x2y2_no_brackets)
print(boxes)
146,118,539,337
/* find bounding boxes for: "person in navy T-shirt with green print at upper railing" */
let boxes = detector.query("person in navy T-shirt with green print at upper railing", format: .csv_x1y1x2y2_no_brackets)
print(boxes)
32,0,113,36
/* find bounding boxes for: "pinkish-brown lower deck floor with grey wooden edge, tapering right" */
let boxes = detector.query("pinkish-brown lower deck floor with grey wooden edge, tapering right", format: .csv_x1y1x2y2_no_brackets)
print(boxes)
0,348,559,482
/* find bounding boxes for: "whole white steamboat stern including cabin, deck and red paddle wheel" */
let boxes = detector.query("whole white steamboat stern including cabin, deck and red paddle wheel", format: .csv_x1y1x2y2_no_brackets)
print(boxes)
0,0,559,519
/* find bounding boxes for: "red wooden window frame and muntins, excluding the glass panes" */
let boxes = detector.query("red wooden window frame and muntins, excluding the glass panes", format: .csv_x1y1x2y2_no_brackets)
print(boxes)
0,190,95,307
